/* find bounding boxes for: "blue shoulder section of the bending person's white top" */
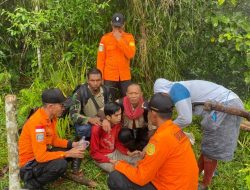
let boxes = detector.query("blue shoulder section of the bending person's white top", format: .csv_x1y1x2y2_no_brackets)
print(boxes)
169,83,190,104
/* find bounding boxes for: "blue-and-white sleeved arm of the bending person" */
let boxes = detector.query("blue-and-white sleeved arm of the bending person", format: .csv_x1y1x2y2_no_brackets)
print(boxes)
169,83,193,128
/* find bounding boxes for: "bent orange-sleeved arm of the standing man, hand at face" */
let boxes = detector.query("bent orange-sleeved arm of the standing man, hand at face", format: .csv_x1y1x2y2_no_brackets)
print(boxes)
117,34,135,59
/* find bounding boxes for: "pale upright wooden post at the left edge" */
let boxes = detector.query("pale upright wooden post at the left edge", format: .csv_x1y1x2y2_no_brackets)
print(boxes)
5,95,20,190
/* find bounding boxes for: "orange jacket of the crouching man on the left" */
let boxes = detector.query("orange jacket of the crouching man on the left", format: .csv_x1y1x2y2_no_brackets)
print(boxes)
18,108,68,167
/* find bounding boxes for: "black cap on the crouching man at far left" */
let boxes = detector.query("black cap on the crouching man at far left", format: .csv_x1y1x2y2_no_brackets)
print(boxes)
42,88,67,104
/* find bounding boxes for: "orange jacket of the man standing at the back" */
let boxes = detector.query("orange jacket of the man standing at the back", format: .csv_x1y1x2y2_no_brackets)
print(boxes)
97,32,135,81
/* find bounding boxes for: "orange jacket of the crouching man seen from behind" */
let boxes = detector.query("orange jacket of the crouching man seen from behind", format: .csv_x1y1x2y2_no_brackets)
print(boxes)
115,120,198,190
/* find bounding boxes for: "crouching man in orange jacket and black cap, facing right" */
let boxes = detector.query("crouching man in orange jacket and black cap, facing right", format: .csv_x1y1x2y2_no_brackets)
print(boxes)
19,88,84,190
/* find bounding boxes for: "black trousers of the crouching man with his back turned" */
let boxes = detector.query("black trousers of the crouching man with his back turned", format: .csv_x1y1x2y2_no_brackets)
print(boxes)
108,170,156,190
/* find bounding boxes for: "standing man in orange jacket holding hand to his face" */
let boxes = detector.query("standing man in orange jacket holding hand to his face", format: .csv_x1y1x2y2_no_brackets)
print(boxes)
97,13,135,98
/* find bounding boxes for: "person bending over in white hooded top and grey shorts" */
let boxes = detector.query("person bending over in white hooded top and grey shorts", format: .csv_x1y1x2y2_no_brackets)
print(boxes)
154,78,243,190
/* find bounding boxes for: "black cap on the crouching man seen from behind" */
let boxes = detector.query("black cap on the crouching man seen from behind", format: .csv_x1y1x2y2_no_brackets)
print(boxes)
144,93,174,113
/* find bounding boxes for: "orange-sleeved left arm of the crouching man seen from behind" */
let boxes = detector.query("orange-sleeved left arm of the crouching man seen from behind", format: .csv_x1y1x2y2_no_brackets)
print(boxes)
115,140,168,186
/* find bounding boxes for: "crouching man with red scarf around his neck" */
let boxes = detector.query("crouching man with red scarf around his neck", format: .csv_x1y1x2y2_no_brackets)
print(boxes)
118,83,155,151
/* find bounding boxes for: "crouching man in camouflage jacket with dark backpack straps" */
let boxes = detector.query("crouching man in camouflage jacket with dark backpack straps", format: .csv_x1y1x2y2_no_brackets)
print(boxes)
70,68,111,175
